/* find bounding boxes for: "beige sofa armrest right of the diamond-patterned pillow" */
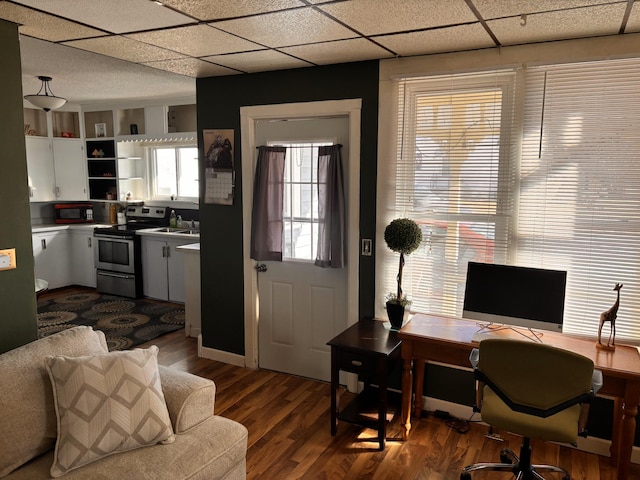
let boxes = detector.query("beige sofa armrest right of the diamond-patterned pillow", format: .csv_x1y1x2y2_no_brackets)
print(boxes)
159,365,216,433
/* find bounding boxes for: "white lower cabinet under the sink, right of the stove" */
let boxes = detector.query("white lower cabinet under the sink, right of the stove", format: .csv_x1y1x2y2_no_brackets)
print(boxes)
142,235,193,303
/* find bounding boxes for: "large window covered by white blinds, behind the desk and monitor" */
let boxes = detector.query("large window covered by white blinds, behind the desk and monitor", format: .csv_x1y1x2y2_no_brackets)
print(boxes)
377,60,640,340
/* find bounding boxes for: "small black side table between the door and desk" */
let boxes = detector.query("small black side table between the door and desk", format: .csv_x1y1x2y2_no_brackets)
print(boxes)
327,319,402,450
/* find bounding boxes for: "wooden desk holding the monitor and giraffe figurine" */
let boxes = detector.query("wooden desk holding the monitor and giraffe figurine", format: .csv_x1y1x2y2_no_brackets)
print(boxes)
398,315,640,480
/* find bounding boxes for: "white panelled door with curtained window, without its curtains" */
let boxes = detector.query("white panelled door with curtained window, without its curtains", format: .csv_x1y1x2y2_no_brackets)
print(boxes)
256,117,349,381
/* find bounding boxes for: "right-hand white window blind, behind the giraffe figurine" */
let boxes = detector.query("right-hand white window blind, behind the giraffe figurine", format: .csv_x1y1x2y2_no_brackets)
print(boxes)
516,59,640,340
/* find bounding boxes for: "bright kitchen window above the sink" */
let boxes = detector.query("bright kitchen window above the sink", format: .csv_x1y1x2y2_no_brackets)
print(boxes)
150,146,199,201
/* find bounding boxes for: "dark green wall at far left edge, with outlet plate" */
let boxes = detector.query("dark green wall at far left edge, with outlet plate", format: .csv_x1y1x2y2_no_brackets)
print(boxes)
0,20,37,353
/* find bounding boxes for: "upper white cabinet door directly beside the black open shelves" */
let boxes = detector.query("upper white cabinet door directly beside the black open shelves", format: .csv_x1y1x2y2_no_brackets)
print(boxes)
52,138,89,201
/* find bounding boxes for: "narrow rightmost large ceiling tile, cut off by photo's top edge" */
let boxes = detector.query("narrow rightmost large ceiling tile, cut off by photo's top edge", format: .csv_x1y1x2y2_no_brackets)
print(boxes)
473,0,627,20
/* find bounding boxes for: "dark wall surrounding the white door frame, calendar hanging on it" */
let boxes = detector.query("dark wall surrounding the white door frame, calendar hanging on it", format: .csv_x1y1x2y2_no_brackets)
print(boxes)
196,61,378,355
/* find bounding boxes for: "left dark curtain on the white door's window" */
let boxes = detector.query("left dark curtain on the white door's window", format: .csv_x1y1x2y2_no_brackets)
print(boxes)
251,146,287,262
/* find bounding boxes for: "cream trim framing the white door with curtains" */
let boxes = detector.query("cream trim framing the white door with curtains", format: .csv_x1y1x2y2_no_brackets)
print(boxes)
240,98,362,368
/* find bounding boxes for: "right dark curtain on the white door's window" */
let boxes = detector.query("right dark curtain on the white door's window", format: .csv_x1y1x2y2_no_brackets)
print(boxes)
315,145,347,268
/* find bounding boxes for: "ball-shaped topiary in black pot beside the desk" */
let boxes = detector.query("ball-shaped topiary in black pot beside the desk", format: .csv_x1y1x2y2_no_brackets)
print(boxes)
384,218,422,330
